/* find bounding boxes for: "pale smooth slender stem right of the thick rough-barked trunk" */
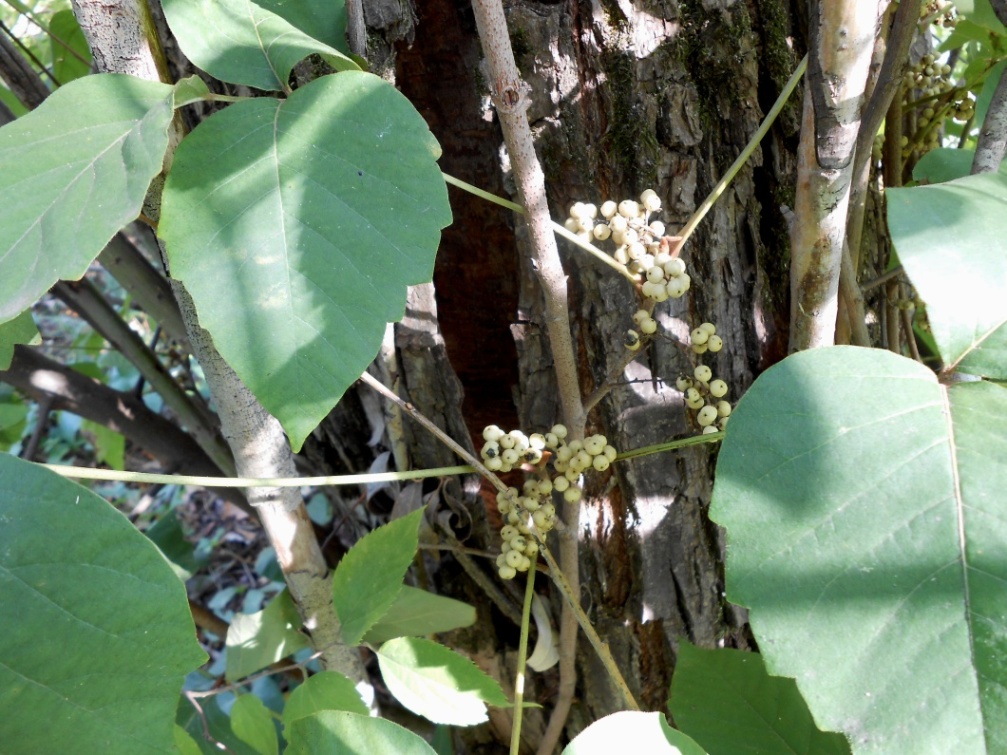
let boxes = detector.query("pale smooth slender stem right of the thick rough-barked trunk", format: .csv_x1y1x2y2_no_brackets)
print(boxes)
790,0,880,351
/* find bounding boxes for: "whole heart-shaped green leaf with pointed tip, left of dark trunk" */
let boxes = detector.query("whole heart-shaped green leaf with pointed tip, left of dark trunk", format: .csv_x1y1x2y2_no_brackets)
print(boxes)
159,71,451,450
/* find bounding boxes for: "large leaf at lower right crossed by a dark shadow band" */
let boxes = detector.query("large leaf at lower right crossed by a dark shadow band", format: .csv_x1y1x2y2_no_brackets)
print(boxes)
710,346,1007,753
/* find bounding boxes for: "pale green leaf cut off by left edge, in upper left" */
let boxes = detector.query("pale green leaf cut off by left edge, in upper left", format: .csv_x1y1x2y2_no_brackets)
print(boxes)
0,73,172,322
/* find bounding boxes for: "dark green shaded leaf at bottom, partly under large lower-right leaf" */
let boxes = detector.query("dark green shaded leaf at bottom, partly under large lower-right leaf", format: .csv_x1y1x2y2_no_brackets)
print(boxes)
670,642,850,755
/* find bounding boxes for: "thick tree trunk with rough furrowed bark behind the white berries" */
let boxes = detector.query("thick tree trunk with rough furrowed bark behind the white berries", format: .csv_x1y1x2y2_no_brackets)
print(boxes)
368,0,805,751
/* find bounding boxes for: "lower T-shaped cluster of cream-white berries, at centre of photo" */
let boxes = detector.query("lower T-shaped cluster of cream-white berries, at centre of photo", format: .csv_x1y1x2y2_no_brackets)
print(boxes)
481,425,618,579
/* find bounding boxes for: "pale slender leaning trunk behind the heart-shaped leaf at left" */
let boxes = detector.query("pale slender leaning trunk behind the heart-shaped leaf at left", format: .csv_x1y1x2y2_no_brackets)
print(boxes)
74,0,367,694
